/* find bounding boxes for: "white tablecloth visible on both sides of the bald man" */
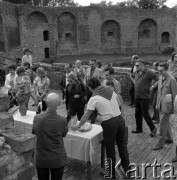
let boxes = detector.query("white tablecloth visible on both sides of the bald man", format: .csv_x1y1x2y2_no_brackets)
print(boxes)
13,110,103,163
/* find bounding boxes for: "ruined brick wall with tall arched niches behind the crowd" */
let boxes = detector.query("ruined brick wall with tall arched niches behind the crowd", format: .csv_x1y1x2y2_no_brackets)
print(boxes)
0,3,177,63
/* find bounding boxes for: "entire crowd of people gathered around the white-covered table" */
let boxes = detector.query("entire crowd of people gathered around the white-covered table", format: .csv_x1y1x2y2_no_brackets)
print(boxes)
5,49,177,180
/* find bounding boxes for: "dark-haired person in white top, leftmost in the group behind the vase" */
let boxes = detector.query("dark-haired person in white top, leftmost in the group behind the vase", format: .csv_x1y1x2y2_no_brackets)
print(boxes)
5,64,18,108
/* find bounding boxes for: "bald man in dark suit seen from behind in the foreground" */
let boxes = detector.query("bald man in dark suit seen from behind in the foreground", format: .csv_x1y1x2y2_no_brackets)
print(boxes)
33,93,68,180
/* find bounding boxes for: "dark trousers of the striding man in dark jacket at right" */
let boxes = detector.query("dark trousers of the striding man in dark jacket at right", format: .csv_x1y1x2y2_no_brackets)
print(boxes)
135,98,155,131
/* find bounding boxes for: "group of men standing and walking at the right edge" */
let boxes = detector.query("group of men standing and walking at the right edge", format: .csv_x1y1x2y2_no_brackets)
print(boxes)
130,53,177,158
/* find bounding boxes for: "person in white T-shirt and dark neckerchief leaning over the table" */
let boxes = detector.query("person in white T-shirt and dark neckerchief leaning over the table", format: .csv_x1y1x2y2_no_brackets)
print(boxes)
72,77,130,179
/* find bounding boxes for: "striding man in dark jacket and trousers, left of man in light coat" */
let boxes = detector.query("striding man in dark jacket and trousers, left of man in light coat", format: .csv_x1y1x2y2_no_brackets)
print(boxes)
132,59,158,137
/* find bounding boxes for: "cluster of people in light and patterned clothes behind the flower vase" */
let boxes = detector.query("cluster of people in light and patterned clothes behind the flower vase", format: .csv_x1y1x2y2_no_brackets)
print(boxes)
5,49,50,116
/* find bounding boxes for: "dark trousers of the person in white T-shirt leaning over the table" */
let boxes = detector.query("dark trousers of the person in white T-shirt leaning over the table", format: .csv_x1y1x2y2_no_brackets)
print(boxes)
101,115,130,178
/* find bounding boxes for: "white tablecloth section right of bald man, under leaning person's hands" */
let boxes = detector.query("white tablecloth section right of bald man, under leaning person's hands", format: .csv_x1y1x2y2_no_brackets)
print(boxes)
64,124,103,163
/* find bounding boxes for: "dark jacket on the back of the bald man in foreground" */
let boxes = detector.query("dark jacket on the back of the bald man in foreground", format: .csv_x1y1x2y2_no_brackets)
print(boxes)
33,111,67,168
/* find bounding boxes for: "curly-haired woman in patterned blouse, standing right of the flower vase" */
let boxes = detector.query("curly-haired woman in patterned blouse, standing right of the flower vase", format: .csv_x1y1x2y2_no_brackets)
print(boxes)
33,67,50,111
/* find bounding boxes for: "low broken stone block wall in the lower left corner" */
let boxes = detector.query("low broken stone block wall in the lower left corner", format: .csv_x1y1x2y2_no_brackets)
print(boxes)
0,93,36,180
